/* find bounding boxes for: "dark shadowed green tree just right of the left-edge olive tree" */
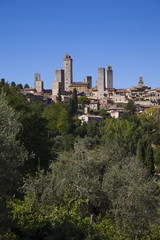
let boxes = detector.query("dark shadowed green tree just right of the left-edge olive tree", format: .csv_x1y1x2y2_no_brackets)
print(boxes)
20,103,51,174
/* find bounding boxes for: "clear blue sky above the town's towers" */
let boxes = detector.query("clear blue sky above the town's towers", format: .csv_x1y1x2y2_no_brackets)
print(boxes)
0,0,160,88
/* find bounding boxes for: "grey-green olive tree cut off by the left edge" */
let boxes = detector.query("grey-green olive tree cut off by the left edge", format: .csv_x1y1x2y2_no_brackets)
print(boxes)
0,94,28,196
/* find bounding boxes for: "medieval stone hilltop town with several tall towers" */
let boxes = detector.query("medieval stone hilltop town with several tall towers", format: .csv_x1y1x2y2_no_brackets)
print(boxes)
21,53,160,118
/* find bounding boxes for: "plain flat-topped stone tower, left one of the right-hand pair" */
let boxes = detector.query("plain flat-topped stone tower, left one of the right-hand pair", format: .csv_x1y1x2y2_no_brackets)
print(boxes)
97,68,105,99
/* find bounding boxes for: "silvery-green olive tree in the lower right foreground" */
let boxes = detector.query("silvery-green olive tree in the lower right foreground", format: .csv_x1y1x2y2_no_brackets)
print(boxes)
103,158,159,239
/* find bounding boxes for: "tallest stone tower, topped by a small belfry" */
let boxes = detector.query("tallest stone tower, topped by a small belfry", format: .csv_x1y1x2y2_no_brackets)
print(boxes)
63,53,72,91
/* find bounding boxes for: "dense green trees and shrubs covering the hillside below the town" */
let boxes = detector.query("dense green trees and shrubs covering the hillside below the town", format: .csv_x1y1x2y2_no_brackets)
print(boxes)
0,79,160,240
